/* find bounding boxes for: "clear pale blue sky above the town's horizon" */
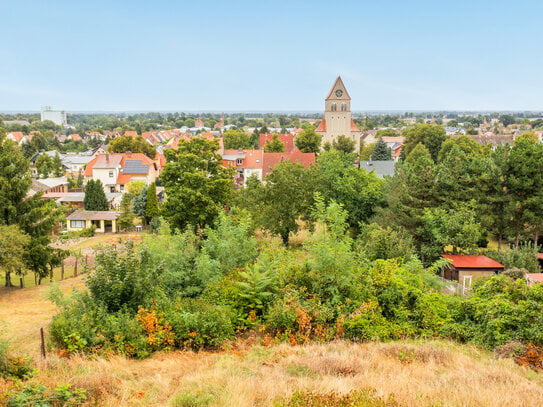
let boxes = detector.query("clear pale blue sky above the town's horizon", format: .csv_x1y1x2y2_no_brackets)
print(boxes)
0,0,543,111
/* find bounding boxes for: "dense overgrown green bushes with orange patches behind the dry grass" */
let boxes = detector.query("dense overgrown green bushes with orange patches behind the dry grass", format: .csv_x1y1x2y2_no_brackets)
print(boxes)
46,196,543,358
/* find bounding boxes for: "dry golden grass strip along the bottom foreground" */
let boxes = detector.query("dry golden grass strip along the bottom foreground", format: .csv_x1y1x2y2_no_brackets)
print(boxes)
26,341,543,407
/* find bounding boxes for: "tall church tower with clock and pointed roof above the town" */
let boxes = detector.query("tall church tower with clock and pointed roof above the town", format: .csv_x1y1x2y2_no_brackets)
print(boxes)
316,76,362,152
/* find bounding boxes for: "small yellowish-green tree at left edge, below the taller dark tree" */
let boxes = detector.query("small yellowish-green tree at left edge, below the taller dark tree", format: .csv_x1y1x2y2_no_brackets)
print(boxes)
0,225,30,287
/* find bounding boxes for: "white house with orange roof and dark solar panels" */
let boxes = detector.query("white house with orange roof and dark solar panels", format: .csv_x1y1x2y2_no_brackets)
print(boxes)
84,153,159,192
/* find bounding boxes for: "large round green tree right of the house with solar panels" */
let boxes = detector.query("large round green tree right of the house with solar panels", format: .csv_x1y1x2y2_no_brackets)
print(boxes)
161,137,233,230
